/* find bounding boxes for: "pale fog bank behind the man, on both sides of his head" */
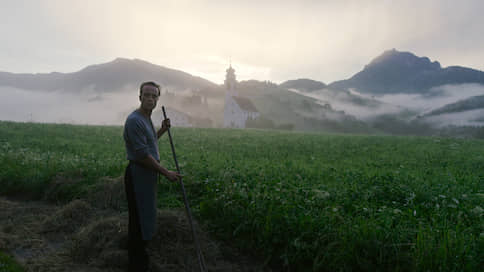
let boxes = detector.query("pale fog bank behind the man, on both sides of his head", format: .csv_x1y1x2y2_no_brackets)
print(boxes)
0,87,223,127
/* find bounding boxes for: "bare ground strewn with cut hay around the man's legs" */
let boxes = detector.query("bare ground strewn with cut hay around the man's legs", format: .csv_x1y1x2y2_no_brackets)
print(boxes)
0,178,267,272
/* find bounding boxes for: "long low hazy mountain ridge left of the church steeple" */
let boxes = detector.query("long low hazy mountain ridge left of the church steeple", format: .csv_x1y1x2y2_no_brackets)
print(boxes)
0,58,218,93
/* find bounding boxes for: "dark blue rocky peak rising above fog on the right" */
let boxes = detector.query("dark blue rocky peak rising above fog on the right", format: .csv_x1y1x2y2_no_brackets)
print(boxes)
329,49,484,95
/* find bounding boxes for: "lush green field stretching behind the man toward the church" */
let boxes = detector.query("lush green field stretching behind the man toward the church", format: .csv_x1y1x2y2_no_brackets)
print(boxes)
0,122,484,271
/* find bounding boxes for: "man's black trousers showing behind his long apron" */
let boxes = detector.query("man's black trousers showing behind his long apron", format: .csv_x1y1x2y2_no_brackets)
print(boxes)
124,165,149,272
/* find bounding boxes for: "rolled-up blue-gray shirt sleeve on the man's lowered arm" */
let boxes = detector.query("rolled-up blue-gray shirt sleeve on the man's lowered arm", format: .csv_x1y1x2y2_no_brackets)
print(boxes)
124,118,150,161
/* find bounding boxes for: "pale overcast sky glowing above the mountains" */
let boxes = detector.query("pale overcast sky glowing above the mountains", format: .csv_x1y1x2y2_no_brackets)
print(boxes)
0,0,484,83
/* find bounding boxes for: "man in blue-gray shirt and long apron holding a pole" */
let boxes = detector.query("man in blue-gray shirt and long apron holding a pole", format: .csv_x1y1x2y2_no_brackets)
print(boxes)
123,81,180,272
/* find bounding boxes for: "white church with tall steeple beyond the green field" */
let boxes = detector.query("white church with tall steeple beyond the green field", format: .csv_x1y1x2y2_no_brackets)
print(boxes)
224,65,259,128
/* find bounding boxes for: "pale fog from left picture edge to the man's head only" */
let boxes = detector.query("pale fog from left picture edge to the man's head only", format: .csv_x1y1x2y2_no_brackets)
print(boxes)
0,87,139,125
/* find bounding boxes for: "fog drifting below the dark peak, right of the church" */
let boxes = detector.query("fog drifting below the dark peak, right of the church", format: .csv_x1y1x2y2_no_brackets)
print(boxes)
290,84,484,126
